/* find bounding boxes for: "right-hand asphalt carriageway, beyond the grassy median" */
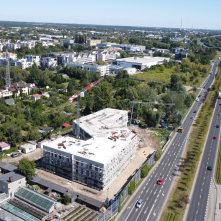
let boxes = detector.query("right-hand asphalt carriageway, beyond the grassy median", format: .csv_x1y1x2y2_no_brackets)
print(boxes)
185,60,221,221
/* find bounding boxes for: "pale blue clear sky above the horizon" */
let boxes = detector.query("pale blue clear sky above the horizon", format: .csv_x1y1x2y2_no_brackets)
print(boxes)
0,0,221,30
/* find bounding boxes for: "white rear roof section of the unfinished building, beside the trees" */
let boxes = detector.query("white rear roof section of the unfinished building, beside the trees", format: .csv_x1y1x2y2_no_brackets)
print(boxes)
73,108,128,137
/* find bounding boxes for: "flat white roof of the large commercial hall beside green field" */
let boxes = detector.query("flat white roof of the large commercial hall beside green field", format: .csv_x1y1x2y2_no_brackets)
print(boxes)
117,56,170,64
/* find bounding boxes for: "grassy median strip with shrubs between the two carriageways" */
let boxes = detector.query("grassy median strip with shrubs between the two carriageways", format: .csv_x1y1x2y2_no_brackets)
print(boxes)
160,64,221,221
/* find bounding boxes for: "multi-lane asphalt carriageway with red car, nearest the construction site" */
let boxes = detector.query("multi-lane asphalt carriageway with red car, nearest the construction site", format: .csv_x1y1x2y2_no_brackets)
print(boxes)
116,61,221,221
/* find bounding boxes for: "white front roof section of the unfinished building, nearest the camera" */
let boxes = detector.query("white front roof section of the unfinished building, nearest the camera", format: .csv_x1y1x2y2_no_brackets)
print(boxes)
44,128,136,165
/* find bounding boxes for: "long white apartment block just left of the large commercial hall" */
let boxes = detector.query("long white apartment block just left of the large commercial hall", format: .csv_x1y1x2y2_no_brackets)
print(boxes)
67,62,110,77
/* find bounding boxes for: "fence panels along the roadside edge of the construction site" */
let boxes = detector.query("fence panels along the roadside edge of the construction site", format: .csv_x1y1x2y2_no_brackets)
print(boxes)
93,151,156,221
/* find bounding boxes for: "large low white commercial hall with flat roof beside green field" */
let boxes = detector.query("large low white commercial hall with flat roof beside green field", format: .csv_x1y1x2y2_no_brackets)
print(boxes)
113,57,170,70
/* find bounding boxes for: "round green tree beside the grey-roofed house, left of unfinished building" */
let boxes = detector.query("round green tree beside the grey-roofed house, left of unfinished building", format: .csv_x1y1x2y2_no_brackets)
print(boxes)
18,158,36,180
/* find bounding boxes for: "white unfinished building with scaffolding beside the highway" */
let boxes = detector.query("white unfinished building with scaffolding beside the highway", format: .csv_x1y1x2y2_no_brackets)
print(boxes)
42,108,138,190
